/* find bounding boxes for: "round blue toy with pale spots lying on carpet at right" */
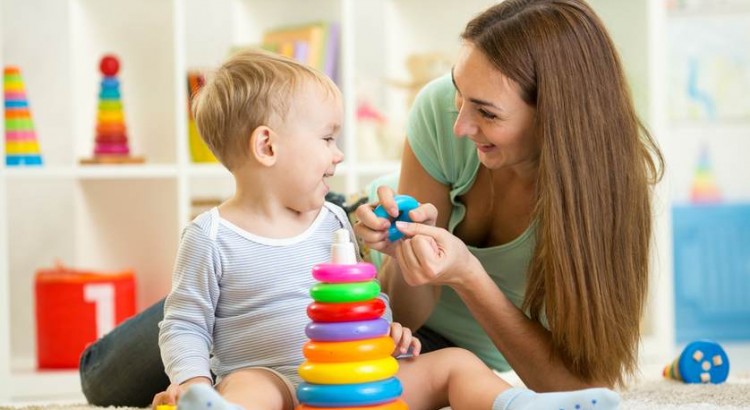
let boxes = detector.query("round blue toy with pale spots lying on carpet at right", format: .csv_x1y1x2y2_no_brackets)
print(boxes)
662,340,729,384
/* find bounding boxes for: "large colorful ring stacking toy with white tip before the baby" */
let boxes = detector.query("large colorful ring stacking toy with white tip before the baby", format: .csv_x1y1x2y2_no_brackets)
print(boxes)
297,229,408,410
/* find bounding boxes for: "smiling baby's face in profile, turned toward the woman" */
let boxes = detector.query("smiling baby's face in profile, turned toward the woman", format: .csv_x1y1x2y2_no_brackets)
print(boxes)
277,83,344,212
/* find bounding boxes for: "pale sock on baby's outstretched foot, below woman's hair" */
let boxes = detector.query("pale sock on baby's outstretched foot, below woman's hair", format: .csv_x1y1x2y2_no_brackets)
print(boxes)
492,387,620,410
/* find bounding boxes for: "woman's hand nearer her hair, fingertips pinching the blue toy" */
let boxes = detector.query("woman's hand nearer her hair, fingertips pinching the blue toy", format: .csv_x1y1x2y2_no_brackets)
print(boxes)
396,222,484,287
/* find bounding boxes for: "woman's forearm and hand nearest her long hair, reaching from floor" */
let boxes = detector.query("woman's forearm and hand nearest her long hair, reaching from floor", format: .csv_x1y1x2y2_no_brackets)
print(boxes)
397,223,605,392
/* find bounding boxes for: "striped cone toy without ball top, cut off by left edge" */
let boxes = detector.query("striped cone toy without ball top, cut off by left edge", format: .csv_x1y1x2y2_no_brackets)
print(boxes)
3,66,42,166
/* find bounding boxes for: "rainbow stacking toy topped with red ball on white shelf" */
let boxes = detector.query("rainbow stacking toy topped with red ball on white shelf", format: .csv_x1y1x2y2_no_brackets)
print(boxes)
81,55,143,164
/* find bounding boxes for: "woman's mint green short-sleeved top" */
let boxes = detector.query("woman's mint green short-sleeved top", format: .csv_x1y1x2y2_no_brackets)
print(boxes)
407,75,536,371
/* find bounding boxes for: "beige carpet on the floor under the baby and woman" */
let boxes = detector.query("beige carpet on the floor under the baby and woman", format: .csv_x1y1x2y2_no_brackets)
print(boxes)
0,373,750,410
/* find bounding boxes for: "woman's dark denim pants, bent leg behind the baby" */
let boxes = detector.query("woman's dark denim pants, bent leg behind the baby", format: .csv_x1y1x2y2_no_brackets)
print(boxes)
80,299,454,407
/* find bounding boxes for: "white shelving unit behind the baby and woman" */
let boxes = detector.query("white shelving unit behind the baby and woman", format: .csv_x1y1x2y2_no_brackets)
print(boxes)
0,0,680,403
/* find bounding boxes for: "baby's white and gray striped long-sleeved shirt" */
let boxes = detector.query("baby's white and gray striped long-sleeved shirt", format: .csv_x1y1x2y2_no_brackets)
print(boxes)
159,203,390,384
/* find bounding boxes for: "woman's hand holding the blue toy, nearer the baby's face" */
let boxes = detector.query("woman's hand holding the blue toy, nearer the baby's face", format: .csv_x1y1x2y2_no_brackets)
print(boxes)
354,185,437,256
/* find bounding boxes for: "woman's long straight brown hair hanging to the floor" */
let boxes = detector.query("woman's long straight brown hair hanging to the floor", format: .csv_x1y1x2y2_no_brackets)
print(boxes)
461,0,663,385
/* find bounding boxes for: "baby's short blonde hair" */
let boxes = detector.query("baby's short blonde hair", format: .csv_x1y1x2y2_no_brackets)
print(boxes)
192,49,339,170
